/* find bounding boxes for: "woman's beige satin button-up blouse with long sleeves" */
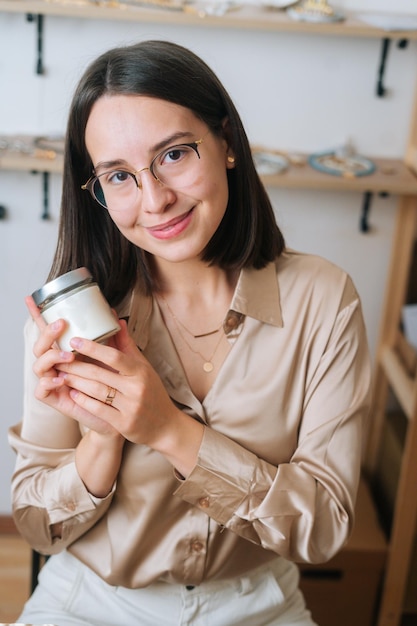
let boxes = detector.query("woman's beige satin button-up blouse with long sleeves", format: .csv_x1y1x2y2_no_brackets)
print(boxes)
9,251,370,587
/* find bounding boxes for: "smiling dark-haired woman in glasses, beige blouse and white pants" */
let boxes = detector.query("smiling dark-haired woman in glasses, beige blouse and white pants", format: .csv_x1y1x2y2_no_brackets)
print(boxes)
10,41,370,626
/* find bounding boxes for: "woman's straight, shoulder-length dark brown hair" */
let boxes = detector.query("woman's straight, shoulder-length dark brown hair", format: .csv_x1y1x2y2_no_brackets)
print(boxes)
49,41,284,306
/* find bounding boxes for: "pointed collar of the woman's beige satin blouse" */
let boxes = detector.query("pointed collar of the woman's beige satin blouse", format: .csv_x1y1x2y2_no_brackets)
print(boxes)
128,263,282,350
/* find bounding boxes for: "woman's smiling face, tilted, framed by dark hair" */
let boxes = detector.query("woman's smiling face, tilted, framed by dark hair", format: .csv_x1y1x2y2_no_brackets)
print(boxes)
85,95,233,262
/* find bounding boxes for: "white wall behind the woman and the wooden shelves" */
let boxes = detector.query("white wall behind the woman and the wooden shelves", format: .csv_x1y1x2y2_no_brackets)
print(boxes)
0,0,417,514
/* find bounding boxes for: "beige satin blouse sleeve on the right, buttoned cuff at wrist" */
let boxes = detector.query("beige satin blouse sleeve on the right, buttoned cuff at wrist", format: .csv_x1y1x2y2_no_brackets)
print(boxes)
172,281,370,563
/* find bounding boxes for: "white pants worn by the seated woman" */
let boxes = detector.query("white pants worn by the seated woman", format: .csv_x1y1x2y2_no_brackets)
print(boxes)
17,552,315,626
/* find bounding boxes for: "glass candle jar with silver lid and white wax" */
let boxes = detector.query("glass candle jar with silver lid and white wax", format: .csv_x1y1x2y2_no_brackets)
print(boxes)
32,267,120,352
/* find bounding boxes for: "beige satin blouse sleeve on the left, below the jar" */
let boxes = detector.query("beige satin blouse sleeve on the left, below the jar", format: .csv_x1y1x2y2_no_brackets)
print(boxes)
9,320,115,554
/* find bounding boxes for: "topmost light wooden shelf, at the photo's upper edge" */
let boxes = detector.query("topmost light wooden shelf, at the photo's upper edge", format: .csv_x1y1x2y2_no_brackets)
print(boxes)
0,0,417,39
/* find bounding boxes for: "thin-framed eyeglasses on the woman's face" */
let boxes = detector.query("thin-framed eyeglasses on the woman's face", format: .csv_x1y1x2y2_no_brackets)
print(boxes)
81,137,204,211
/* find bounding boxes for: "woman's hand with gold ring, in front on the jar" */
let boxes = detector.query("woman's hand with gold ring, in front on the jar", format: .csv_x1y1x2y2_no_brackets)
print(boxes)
59,320,202,464
